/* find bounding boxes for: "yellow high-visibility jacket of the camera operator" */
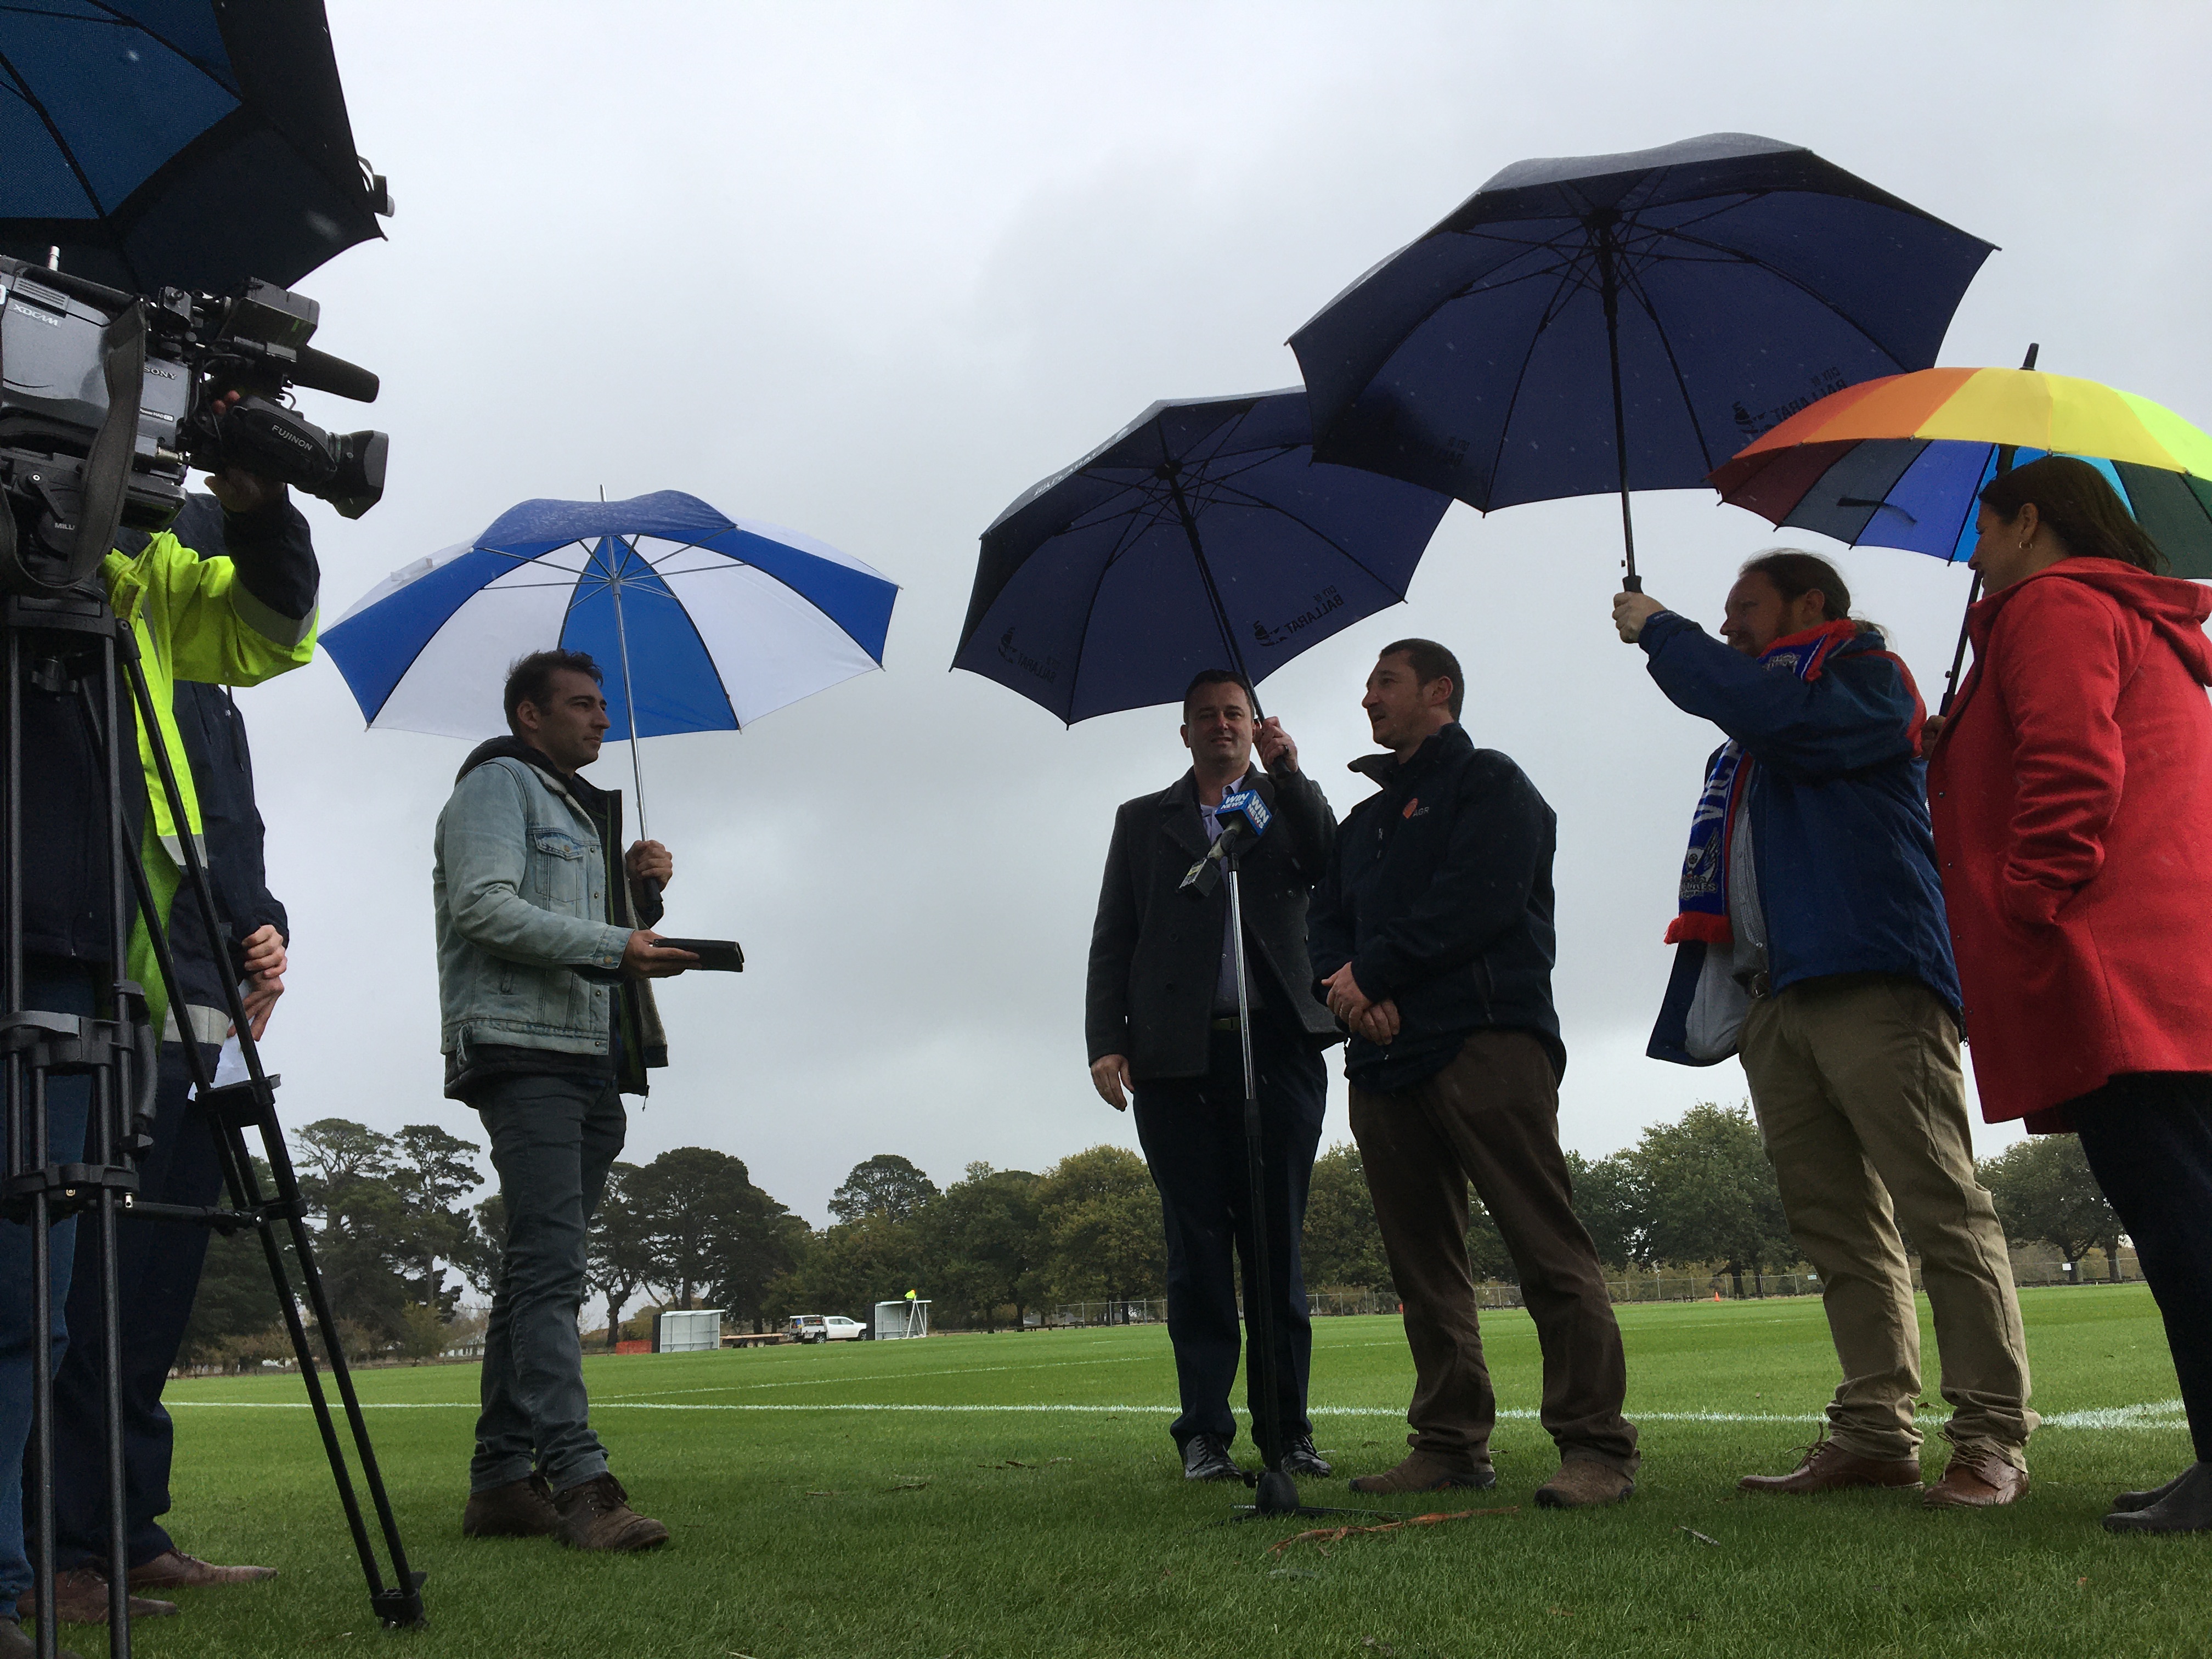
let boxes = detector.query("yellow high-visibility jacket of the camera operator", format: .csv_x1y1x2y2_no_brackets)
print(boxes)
99,531,317,1029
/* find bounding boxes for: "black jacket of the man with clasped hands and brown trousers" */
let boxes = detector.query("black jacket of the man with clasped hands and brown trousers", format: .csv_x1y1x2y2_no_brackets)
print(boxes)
1307,723,1566,1093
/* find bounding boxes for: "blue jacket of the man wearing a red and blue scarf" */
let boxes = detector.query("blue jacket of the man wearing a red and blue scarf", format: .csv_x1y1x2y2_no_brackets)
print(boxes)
1637,611,1960,1066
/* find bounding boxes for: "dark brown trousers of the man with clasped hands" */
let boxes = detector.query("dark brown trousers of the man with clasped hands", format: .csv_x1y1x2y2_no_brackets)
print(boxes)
1352,1031,1639,1473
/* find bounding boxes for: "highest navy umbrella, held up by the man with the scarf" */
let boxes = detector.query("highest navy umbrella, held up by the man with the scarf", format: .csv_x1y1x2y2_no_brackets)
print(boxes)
1290,133,1991,584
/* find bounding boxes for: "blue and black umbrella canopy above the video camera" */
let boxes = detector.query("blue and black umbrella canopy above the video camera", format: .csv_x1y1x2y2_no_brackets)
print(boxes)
0,0,392,294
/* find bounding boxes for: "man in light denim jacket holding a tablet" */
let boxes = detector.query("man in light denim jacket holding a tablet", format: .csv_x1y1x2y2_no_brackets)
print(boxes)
433,650,699,1550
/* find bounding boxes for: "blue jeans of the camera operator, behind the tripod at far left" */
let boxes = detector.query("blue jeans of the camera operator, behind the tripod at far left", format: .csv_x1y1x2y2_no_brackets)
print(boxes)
0,958,104,1619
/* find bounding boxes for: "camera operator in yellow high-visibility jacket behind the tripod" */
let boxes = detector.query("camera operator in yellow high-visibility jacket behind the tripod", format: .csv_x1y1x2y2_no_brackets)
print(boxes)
0,473,317,1659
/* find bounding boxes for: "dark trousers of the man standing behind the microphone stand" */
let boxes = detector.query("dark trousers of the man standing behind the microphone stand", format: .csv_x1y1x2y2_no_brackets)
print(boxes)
1135,1013,1329,1462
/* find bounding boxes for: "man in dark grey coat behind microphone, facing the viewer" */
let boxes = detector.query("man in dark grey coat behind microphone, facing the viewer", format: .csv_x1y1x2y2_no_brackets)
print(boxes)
1084,668,1336,1480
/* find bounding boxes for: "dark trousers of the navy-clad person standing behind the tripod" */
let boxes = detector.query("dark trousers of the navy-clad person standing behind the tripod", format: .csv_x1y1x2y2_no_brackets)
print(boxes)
53,1042,225,1568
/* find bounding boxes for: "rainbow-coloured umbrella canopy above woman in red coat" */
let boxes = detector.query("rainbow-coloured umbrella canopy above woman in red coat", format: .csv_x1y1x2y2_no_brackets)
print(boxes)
1712,369,2212,577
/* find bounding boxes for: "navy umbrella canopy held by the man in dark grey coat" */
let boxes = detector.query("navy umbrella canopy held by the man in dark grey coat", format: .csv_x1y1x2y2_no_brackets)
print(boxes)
953,387,1451,725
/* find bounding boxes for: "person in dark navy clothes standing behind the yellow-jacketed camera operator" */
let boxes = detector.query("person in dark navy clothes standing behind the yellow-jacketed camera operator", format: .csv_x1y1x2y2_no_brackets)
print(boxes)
38,478,314,1621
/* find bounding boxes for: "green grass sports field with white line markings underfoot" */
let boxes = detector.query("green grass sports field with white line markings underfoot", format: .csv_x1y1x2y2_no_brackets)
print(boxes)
112,1285,2212,1659
